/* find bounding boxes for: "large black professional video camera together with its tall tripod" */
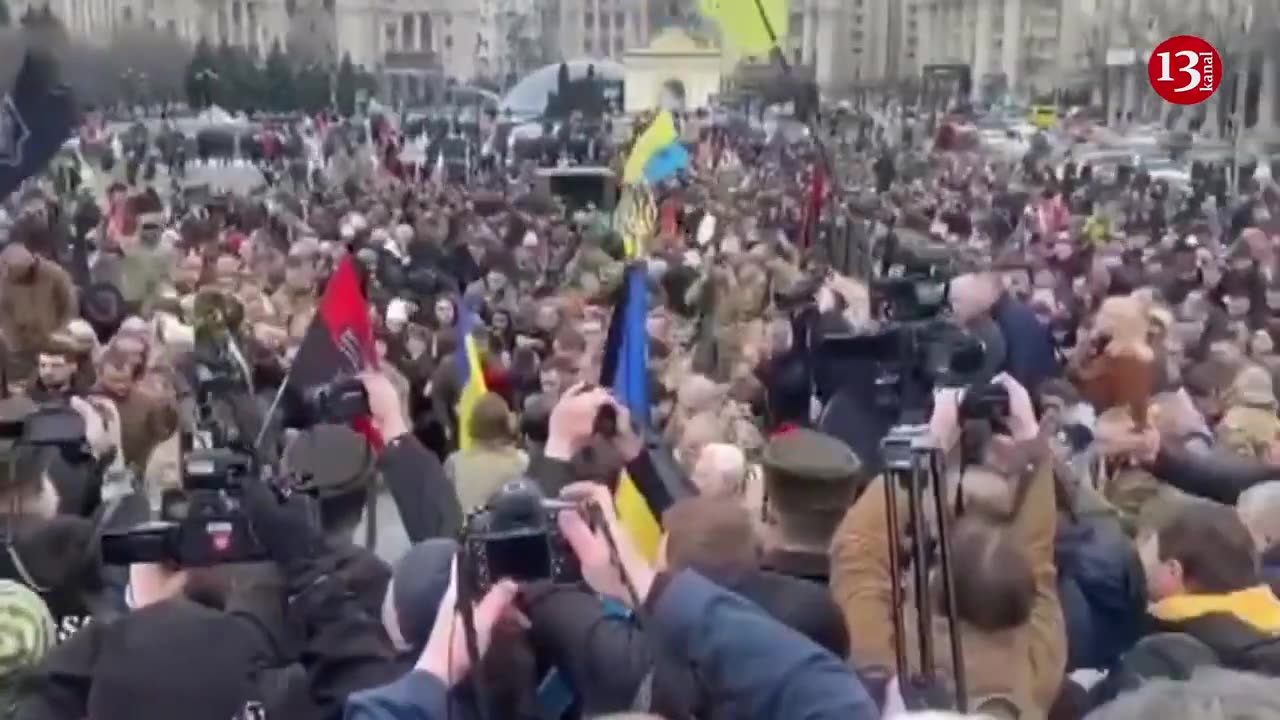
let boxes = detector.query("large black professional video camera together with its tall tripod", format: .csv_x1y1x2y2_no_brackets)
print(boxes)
817,242,993,711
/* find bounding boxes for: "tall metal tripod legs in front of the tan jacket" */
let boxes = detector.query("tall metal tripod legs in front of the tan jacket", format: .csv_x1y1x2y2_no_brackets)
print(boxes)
881,424,968,712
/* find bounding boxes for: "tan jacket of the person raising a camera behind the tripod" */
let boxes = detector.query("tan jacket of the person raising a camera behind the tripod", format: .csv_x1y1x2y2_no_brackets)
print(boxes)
831,462,1066,720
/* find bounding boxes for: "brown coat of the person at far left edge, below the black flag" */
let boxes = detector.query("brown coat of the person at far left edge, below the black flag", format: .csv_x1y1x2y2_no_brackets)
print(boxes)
0,260,78,354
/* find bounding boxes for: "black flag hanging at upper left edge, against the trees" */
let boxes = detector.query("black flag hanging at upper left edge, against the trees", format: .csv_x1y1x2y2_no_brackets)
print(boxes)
0,50,76,200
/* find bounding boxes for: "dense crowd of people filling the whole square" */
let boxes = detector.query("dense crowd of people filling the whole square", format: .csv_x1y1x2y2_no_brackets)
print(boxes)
0,83,1280,720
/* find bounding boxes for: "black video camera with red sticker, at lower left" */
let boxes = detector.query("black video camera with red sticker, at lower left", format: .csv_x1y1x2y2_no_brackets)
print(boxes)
102,448,268,568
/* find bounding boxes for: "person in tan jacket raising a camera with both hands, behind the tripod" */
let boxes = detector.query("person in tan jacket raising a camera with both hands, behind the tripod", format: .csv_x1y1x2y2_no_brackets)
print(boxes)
831,374,1066,717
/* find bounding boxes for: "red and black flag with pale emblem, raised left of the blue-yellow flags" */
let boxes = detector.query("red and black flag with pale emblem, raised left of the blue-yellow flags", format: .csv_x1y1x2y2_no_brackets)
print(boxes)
285,256,383,450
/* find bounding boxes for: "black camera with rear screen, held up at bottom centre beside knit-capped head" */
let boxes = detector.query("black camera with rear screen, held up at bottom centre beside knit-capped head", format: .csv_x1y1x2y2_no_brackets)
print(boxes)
460,479,582,597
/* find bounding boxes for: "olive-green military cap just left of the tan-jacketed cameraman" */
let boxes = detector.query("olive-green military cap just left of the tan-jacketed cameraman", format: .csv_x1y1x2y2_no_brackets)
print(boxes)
760,428,863,511
